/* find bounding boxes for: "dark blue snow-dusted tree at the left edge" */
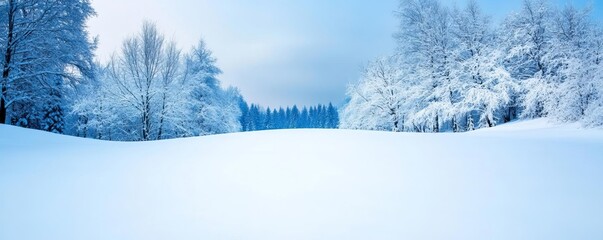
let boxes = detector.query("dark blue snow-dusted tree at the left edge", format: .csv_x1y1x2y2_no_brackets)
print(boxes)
0,0,95,126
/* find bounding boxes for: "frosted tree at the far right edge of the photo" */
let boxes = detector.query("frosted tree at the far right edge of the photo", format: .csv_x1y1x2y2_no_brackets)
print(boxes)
547,5,598,121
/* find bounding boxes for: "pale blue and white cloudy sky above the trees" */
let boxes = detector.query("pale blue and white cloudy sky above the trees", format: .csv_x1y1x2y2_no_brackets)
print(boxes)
88,0,603,107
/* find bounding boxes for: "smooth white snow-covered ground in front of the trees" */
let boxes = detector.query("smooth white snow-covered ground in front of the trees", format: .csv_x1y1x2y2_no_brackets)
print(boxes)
0,120,603,240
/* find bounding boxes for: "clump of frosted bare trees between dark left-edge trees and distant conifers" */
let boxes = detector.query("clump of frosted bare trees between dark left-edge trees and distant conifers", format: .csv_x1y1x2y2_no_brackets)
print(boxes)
71,22,243,141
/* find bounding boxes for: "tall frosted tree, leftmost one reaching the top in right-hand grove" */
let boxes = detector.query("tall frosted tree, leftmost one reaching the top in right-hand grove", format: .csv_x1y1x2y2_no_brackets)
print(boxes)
395,0,453,132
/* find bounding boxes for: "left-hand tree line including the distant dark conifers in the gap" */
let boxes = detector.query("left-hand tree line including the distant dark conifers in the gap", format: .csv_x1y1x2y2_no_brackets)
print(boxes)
0,0,338,141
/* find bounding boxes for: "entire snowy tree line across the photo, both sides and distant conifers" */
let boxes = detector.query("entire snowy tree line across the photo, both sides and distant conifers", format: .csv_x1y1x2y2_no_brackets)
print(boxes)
0,0,603,141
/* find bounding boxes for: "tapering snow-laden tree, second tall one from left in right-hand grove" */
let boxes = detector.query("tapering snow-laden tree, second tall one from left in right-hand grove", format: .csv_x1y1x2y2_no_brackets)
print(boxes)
449,1,518,131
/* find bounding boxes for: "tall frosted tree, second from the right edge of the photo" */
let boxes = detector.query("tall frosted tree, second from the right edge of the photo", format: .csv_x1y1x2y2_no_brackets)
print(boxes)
501,0,558,118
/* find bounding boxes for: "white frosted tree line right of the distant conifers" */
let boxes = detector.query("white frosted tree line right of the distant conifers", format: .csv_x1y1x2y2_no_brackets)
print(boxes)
341,0,603,132
